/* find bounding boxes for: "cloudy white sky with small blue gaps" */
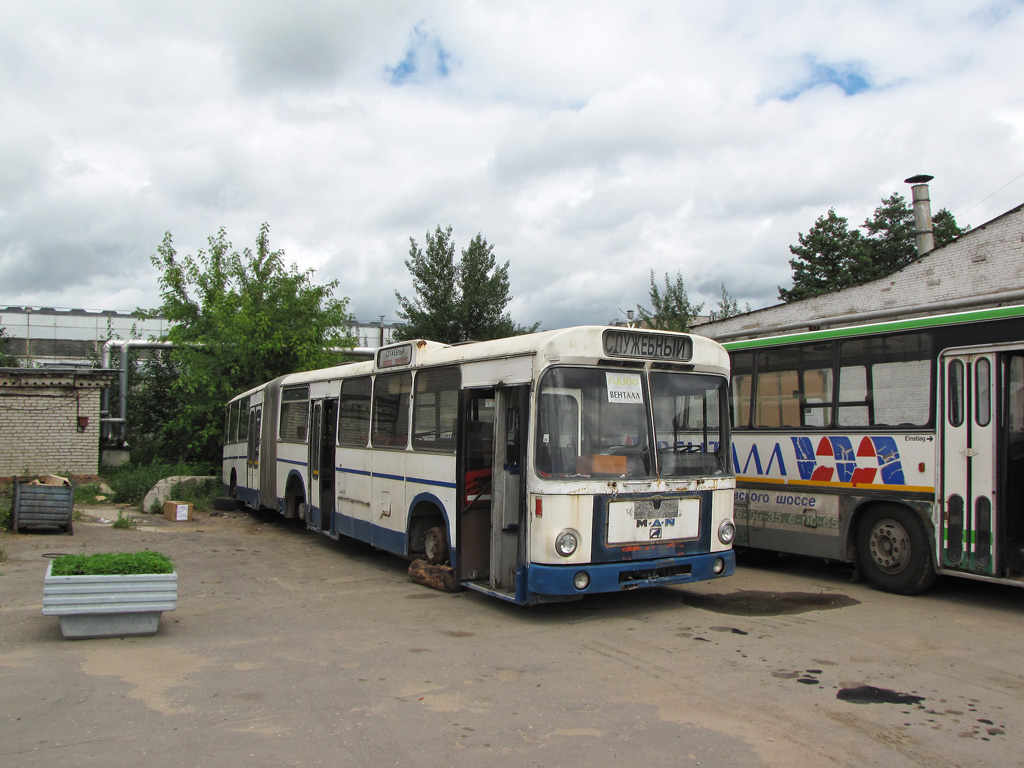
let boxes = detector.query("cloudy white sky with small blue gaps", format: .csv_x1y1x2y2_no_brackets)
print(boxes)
0,0,1024,328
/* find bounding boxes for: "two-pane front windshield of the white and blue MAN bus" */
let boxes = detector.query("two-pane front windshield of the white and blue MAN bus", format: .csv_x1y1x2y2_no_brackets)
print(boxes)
537,368,728,479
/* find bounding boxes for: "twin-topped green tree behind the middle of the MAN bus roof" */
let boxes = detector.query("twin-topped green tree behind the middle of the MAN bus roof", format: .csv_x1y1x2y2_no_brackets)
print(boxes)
394,226,540,344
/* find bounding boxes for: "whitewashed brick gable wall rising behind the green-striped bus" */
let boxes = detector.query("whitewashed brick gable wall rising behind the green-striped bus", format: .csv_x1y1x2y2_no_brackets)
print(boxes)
693,206,1024,339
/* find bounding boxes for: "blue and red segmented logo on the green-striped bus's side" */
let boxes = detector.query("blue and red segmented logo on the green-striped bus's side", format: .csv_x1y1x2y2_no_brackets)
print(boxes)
792,435,905,485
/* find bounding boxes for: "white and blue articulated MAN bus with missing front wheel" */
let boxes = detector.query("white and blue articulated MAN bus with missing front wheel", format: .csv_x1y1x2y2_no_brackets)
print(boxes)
223,327,735,604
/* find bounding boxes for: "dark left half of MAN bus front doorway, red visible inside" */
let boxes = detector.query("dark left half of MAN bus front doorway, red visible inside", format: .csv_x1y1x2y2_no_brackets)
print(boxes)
456,389,495,582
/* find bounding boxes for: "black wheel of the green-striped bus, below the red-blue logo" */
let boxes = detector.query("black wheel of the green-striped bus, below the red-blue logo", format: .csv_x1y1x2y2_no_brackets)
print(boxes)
857,505,936,595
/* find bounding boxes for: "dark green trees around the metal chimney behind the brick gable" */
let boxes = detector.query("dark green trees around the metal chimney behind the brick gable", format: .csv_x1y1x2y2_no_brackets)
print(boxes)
778,193,970,302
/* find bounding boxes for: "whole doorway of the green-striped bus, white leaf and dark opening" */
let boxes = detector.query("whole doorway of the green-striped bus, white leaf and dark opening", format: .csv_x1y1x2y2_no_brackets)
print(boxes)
939,349,1024,578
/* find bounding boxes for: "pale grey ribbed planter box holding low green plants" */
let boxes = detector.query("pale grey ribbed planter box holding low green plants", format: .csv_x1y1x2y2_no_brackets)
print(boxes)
43,562,178,639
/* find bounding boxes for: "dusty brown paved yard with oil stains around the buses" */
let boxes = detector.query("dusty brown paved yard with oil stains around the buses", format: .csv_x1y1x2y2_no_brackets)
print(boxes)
0,508,1024,768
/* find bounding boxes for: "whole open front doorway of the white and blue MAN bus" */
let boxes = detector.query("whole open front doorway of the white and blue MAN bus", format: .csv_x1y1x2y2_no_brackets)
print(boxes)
456,386,529,594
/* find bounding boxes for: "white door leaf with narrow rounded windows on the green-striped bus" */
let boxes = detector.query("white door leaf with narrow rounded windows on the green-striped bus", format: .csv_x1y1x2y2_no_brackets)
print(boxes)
938,352,998,575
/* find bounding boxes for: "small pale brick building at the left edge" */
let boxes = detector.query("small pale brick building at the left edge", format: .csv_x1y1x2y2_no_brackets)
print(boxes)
0,368,117,479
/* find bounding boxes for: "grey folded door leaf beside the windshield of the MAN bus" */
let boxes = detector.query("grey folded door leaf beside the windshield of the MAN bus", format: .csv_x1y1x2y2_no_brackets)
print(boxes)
489,387,529,591
